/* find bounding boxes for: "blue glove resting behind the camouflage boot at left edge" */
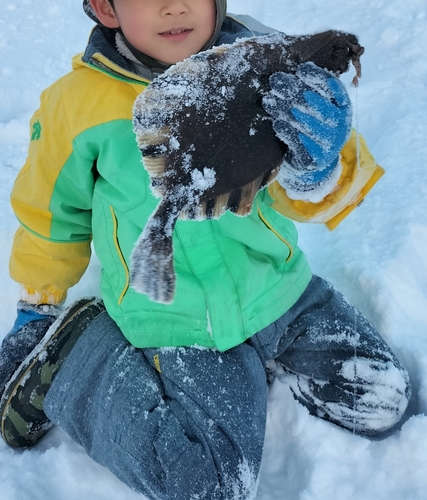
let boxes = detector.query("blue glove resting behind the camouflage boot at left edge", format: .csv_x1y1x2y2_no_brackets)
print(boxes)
0,301,61,395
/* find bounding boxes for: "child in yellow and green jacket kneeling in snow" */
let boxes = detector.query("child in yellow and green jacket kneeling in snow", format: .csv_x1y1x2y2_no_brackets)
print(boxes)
0,0,410,500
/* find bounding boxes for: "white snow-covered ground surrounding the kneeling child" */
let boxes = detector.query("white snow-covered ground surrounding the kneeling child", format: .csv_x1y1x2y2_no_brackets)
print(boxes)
0,0,427,500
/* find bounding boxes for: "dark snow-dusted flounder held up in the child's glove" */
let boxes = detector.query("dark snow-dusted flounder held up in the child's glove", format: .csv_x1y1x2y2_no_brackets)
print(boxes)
131,31,363,303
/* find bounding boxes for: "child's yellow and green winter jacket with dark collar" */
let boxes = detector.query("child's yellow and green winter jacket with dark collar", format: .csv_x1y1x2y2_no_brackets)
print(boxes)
10,18,384,350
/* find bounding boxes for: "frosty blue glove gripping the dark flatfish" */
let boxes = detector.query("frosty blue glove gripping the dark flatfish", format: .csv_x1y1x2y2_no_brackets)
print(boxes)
263,63,352,189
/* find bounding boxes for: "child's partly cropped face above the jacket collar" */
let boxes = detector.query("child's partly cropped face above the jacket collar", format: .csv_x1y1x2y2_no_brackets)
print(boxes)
91,0,216,64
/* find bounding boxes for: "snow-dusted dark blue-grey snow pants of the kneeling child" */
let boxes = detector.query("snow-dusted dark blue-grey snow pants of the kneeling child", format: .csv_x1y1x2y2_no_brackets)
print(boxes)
44,277,410,500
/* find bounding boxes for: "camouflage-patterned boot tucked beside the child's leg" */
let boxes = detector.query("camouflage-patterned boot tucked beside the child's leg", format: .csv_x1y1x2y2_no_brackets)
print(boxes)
0,297,105,448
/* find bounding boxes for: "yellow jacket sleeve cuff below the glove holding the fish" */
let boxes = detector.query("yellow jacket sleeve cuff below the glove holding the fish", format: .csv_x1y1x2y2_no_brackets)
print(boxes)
268,130,384,230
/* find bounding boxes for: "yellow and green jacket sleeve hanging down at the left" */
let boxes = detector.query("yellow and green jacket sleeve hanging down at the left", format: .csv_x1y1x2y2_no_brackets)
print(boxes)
9,70,93,304
